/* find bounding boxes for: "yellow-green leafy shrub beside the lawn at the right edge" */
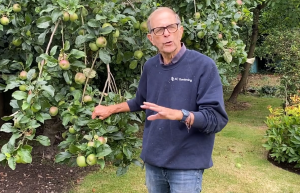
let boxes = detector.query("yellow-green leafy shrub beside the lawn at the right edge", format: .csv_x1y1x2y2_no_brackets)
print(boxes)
263,95,300,167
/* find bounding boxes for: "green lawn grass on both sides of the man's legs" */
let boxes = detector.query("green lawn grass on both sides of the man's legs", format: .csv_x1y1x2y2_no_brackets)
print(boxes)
70,95,300,193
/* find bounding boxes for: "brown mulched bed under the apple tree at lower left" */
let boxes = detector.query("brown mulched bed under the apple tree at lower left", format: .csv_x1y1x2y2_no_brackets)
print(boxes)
0,155,99,193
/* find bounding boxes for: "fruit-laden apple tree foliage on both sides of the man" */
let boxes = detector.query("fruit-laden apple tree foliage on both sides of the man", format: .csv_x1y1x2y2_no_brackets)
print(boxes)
0,0,250,174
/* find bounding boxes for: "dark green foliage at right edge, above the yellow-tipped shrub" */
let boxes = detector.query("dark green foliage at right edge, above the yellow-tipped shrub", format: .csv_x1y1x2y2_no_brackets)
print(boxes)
257,30,300,101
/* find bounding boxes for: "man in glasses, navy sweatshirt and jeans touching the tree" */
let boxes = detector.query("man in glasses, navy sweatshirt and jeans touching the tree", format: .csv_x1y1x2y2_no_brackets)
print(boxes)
92,7,228,193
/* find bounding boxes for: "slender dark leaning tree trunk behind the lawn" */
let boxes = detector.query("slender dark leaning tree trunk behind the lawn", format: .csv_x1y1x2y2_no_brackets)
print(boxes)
228,2,268,103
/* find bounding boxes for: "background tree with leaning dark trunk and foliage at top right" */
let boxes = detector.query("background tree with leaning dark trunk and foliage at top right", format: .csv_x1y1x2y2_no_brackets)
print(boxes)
228,0,299,103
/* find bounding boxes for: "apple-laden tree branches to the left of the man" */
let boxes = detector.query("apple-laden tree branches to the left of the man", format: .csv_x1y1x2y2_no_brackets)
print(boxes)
0,0,156,174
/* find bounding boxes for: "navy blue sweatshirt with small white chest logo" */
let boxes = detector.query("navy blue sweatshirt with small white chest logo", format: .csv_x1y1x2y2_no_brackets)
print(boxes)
127,49,228,169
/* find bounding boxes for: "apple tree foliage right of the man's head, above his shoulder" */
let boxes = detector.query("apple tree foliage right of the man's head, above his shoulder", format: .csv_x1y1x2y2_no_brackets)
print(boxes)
163,0,251,84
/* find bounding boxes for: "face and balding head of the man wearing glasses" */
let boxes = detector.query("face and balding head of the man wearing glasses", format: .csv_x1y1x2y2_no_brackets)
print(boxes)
147,10,183,56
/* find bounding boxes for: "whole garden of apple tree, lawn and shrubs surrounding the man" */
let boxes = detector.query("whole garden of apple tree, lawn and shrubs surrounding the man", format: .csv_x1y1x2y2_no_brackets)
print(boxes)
0,0,300,193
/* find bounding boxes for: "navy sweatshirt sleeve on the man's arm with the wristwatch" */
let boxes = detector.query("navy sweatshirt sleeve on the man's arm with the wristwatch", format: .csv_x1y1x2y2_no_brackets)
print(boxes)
193,60,228,134
